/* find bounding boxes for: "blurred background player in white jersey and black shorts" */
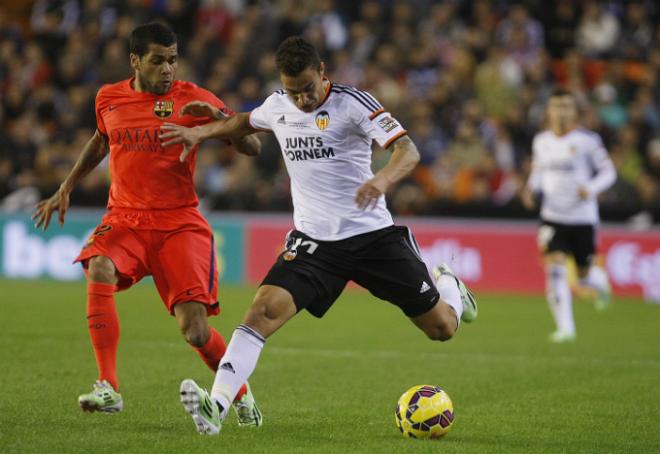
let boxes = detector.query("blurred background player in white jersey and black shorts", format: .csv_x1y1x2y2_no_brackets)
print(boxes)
522,90,616,343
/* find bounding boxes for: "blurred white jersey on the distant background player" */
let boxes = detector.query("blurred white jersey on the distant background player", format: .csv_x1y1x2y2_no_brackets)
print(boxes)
527,128,616,225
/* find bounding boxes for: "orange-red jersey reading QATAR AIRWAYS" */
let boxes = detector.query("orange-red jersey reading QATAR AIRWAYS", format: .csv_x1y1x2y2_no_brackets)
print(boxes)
96,79,233,214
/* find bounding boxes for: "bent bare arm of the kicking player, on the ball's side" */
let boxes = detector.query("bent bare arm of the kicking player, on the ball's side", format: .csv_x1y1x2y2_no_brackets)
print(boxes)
355,136,419,210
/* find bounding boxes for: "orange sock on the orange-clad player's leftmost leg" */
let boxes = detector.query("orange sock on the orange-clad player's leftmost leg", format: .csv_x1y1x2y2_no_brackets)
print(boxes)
87,282,119,391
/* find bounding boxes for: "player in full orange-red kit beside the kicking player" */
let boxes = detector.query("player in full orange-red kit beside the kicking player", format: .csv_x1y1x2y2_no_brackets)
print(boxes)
33,23,262,426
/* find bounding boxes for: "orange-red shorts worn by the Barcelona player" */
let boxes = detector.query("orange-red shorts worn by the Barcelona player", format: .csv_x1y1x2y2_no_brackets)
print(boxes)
75,215,220,315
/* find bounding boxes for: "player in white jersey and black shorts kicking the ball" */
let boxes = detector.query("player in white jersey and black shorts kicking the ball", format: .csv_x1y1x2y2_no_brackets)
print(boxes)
161,37,477,434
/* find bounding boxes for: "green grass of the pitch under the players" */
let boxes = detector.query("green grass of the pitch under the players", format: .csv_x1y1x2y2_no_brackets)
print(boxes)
0,281,660,453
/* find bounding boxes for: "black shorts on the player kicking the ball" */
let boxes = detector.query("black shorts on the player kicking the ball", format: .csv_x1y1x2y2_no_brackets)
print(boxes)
261,226,439,318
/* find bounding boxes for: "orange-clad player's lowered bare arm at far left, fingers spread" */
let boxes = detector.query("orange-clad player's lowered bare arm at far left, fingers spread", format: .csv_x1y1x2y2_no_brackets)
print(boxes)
32,131,109,230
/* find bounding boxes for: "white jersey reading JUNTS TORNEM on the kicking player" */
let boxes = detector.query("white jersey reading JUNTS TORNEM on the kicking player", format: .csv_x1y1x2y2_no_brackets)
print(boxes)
250,83,406,241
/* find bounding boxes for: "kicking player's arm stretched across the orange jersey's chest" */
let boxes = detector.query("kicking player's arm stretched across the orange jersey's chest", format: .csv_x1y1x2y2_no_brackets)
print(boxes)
160,112,258,161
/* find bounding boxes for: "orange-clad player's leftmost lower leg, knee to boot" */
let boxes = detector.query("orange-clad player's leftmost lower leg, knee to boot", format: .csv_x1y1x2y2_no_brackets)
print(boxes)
78,256,124,413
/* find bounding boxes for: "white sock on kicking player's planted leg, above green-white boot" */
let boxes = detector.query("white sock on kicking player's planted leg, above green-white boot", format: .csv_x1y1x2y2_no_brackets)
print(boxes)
211,325,266,416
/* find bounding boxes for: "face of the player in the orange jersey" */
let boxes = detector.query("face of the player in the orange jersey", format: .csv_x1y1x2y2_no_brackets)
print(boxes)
131,44,178,95
